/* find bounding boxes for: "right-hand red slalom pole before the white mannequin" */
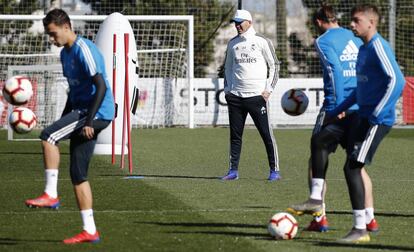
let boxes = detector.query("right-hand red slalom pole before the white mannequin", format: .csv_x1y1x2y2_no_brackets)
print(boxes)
124,33,133,174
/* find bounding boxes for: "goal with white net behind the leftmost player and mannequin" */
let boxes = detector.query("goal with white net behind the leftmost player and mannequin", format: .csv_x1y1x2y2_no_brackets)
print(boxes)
0,15,194,140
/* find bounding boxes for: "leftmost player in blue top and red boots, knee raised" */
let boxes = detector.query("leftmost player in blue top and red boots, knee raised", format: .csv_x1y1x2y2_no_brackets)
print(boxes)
26,9,115,244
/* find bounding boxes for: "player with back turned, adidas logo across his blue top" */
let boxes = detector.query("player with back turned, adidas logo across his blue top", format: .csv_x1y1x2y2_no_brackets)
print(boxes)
288,5,378,232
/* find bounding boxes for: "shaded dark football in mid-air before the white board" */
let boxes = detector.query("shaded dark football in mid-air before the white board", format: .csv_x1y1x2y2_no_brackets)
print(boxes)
281,89,309,116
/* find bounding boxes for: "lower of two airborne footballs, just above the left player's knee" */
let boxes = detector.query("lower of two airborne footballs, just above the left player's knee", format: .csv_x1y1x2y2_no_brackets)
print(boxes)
9,107,36,134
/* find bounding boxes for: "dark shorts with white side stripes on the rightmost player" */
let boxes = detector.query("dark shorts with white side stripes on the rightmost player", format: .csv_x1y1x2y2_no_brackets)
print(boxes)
347,116,391,164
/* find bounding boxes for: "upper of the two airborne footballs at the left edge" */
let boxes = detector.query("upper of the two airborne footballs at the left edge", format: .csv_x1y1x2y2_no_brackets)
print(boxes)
3,76,33,106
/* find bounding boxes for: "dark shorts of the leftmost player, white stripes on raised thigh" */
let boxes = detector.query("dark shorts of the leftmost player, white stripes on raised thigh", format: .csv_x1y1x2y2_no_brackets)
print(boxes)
40,110,110,185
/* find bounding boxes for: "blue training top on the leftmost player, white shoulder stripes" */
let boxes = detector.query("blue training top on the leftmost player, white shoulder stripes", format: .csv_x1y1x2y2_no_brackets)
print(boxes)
60,36,115,120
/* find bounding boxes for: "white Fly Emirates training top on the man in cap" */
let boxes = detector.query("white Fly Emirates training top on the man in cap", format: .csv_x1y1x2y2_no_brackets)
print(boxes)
224,27,279,97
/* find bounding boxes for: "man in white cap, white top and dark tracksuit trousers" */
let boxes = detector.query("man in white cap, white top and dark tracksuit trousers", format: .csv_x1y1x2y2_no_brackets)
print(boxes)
222,10,280,181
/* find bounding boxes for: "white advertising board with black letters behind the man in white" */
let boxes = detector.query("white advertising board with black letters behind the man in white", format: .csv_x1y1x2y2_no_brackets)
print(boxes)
134,78,323,127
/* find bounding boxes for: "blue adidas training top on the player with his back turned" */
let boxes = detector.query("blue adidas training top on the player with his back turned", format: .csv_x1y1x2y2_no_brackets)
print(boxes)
315,27,362,111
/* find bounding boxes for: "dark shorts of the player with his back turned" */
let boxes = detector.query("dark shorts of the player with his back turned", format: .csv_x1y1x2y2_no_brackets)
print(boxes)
312,109,356,152
